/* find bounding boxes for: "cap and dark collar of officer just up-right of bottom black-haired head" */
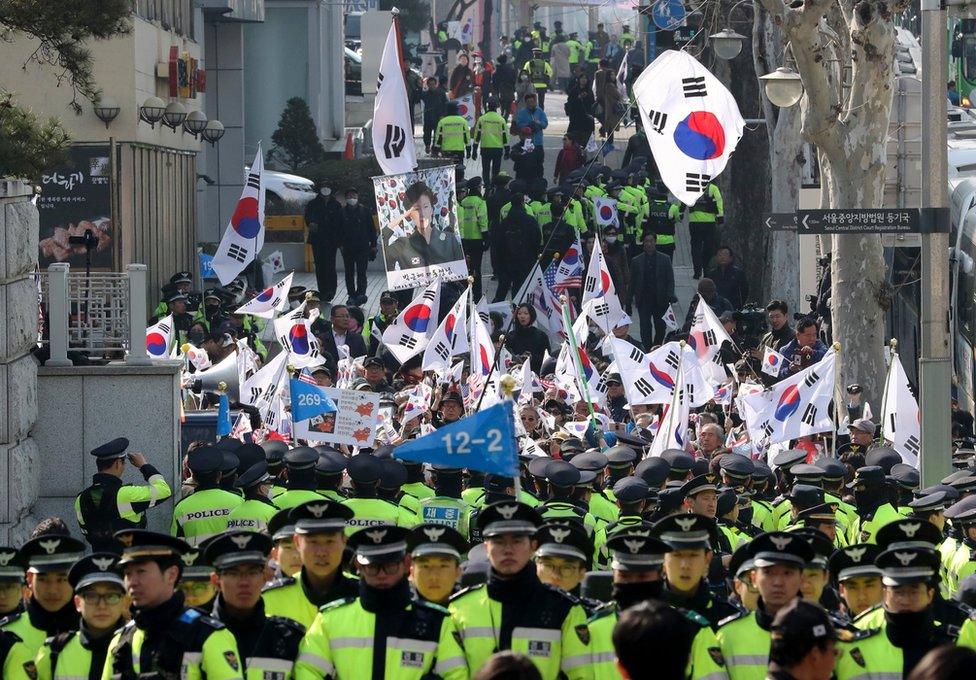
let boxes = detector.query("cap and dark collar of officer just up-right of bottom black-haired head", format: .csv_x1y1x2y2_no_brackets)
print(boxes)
654,513,739,630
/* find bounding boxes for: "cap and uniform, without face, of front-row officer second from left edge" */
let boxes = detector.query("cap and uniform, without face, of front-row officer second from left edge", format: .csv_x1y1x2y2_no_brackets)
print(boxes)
0,535,85,656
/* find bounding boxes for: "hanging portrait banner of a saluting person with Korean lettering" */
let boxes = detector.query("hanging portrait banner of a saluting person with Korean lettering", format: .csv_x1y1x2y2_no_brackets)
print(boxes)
373,165,468,290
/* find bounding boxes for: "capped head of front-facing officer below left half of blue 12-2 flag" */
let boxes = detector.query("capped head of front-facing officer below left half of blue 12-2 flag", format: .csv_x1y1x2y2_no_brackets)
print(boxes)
407,523,469,607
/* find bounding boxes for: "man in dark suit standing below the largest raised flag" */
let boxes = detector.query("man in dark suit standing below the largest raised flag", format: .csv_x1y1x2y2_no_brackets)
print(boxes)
630,232,677,350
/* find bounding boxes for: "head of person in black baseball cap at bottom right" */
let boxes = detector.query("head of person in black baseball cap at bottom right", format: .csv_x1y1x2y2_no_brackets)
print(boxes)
766,600,837,680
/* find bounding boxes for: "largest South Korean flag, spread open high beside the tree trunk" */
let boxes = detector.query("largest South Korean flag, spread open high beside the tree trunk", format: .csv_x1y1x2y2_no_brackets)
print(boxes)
633,50,745,206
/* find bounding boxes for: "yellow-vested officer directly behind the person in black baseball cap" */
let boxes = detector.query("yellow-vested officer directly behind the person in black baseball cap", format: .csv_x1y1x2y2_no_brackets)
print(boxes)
716,531,813,680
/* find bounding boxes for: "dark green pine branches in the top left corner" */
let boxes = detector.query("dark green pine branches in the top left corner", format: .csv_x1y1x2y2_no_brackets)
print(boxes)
0,0,132,179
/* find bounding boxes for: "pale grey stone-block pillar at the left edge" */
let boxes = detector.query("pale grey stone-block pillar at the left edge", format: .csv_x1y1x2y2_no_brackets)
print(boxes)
0,179,39,545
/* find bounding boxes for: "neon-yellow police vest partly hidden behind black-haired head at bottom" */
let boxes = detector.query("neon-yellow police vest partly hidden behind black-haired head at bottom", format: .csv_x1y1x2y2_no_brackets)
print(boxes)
577,604,728,680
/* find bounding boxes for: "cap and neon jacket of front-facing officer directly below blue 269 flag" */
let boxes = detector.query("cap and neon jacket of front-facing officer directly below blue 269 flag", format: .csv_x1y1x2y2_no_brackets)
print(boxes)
261,499,357,629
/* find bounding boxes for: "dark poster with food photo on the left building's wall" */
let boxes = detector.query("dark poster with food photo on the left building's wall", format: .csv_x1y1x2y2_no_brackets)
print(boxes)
37,144,116,269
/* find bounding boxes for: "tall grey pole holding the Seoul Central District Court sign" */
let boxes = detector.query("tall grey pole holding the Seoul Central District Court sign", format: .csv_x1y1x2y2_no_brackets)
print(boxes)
918,0,952,487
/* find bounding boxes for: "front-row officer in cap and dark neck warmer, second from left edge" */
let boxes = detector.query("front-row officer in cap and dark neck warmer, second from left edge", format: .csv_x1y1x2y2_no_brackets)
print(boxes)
0,534,85,656
